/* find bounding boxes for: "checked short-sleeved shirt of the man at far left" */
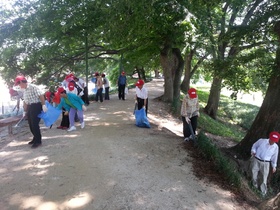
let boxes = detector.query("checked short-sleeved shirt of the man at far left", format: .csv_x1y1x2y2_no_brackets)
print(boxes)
23,84,44,105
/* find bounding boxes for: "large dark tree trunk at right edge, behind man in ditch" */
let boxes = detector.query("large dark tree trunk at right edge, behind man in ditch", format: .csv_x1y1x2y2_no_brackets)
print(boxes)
234,22,280,159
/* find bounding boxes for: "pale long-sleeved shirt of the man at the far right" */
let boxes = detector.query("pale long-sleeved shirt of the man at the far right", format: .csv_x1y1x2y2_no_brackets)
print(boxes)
251,139,279,168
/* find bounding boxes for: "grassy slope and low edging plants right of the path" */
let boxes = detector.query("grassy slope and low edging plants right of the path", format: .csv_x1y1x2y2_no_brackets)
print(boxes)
181,87,259,192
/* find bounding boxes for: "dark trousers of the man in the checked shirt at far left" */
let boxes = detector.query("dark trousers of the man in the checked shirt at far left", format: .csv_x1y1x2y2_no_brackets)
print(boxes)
26,102,42,144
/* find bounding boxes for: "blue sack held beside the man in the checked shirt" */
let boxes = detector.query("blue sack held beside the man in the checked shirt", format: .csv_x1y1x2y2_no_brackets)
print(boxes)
38,101,61,127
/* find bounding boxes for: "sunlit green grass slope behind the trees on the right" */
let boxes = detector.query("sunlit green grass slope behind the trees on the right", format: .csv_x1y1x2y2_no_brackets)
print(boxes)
192,88,259,142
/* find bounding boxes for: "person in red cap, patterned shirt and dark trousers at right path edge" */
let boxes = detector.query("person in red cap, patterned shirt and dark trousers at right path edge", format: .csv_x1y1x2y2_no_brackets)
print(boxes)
181,88,199,141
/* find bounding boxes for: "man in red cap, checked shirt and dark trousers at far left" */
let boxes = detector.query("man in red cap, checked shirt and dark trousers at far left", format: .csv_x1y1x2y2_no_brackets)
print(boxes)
15,75,48,148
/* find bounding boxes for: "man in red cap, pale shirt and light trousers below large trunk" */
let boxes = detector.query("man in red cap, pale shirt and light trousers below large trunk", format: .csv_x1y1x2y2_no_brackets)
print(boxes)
251,131,280,196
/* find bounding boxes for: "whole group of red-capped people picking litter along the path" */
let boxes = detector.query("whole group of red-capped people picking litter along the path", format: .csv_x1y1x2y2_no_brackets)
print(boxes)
11,72,280,195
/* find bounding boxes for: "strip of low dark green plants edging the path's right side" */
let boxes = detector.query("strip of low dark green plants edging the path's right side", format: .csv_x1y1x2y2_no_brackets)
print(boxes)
197,132,241,188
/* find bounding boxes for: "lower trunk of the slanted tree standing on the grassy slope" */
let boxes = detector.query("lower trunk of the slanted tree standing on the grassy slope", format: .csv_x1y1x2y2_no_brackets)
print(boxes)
204,76,223,119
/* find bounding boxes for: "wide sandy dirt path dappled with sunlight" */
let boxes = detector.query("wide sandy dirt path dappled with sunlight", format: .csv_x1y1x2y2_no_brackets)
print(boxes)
0,80,256,210
